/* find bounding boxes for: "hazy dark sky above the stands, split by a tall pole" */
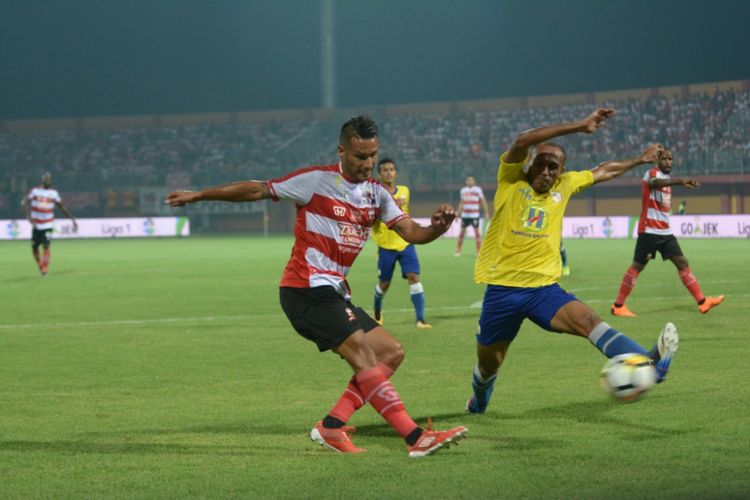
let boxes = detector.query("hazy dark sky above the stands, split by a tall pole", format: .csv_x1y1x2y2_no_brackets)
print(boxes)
0,0,750,118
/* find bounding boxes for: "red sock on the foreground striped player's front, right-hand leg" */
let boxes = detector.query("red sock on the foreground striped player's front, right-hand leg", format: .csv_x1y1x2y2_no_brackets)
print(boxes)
354,366,418,438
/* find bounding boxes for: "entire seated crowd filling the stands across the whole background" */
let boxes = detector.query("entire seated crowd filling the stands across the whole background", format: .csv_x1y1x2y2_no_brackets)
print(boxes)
0,90,750,212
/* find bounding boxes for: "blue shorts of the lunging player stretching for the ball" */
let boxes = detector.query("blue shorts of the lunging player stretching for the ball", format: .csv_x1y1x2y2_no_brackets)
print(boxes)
477,284,578,345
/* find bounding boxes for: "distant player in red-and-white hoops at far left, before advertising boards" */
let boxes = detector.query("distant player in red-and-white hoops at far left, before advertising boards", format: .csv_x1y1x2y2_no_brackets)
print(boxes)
23,172,78,276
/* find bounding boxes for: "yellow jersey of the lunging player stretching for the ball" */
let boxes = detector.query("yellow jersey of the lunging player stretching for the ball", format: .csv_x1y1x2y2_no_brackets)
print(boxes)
474,152,594,288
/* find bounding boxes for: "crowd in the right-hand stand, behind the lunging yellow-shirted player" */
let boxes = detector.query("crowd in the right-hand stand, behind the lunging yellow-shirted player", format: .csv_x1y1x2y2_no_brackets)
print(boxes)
383,91,750,171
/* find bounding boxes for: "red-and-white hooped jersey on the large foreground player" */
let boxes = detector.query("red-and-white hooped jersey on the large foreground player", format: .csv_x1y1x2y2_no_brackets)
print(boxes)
266,164,408,298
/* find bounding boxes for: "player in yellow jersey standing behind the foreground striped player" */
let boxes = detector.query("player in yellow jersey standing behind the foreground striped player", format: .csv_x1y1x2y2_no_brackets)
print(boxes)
372,158,432,330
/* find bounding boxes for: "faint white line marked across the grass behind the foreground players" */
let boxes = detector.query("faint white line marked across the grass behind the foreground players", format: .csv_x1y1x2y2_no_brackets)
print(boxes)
0,292,750,331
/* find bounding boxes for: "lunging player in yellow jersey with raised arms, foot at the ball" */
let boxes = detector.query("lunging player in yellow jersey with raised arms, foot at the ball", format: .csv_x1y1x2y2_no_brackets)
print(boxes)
466,108,678,413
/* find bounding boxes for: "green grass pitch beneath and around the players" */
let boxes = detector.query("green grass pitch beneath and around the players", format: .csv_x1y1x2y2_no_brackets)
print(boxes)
0,237,750,499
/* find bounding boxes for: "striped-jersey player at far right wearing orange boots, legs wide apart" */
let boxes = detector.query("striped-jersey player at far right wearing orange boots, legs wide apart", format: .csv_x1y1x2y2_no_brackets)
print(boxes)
611,150,724,317
